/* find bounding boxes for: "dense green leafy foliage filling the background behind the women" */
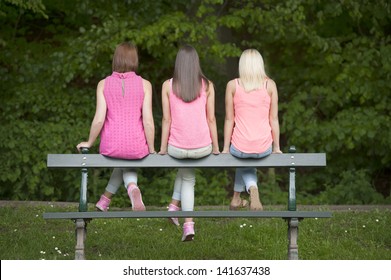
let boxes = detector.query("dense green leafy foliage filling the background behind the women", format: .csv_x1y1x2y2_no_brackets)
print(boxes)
0,0,391,205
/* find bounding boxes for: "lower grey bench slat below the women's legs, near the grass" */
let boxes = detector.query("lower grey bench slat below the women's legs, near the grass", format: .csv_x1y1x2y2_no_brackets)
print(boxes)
43,210,331,219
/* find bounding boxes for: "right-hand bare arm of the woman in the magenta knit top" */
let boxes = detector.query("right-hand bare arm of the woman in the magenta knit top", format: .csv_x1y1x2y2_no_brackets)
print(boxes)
142,79,156,154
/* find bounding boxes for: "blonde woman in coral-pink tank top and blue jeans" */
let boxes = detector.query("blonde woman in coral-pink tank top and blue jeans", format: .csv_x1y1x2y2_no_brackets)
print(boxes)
222,49,281,210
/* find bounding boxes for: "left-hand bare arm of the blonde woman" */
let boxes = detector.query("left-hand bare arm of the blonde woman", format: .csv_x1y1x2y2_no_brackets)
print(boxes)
222,80,236,153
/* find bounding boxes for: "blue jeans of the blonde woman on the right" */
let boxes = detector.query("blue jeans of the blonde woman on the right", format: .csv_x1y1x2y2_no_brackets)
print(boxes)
229,144,272,193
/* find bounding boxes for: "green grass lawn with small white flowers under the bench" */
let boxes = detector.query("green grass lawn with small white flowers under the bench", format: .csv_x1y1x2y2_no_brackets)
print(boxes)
0,205,391,260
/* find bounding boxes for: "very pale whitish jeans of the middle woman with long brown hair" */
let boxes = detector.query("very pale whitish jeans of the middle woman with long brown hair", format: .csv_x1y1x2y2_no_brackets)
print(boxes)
167,145,212,211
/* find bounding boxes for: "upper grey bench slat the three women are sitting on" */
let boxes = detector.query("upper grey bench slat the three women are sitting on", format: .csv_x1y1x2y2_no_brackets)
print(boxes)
47,153,326,168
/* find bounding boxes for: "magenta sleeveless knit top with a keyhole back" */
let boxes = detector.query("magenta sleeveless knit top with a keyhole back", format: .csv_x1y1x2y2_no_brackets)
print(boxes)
100,72,149,159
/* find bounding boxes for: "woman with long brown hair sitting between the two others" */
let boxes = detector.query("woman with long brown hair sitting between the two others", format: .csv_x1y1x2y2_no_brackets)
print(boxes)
159,46,219,241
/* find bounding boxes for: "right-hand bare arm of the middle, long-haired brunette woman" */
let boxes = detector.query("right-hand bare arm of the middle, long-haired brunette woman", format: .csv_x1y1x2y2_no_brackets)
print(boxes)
206,82,220,155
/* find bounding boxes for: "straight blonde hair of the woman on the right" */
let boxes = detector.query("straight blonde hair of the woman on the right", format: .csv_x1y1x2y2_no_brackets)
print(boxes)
239,49,267,92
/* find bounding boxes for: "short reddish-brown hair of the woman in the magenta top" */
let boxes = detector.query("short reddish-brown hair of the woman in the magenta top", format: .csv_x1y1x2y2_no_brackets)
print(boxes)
112,42,138,73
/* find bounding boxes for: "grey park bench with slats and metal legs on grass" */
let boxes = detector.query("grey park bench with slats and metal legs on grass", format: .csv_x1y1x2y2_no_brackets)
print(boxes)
43,147,331,260
